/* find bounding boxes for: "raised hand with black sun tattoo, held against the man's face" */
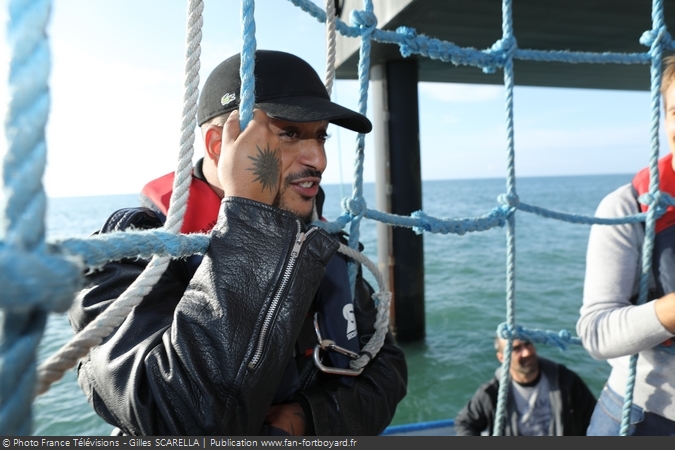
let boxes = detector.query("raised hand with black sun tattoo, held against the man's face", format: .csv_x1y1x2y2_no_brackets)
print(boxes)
218,109,281,205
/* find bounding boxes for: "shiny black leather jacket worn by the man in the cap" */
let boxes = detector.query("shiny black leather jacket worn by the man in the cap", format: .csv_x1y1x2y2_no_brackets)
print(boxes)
70,198,407,436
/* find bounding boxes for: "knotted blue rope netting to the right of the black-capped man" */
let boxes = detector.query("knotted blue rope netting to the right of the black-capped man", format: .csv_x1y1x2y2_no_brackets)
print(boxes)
290,0,675,435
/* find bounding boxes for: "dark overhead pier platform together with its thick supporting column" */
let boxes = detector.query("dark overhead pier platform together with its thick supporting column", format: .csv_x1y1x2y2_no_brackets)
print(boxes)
335,0,675,342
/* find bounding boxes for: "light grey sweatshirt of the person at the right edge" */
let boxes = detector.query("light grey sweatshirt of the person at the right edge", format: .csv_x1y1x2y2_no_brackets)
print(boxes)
577,185,675,420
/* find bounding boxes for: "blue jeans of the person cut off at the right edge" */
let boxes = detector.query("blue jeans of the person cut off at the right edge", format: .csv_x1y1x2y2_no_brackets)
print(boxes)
586,386,675,436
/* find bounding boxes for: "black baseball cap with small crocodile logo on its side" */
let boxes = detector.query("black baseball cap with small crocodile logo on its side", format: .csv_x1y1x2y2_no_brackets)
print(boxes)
197,50,373,133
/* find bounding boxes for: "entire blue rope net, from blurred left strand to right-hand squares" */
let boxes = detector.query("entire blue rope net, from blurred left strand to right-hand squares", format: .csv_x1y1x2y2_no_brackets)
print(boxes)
0,0,675,435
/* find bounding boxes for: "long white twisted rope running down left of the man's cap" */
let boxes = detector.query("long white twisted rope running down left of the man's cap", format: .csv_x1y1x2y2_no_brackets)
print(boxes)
36,0,204,395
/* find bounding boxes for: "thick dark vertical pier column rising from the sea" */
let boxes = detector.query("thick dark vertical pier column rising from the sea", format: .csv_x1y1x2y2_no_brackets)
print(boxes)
371,60,425,342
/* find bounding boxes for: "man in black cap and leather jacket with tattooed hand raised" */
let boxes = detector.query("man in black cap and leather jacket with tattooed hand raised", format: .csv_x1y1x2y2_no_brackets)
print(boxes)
70,51,407,436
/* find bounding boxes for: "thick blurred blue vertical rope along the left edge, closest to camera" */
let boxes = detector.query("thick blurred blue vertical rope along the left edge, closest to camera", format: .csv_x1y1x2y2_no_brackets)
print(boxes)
0,0,54,436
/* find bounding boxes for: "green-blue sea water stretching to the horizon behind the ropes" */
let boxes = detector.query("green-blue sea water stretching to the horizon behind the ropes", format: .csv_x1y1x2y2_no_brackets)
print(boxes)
33,175,631,435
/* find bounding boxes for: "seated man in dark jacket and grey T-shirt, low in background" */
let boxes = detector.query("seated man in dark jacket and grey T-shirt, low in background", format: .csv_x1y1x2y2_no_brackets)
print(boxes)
455,337,595,436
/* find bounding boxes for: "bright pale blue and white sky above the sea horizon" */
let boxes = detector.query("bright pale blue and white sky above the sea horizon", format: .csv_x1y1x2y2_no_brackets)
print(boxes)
0,0,665,197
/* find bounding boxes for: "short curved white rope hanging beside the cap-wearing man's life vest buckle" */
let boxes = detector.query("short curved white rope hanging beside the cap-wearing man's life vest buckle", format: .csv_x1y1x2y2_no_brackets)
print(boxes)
338,244,391,370
